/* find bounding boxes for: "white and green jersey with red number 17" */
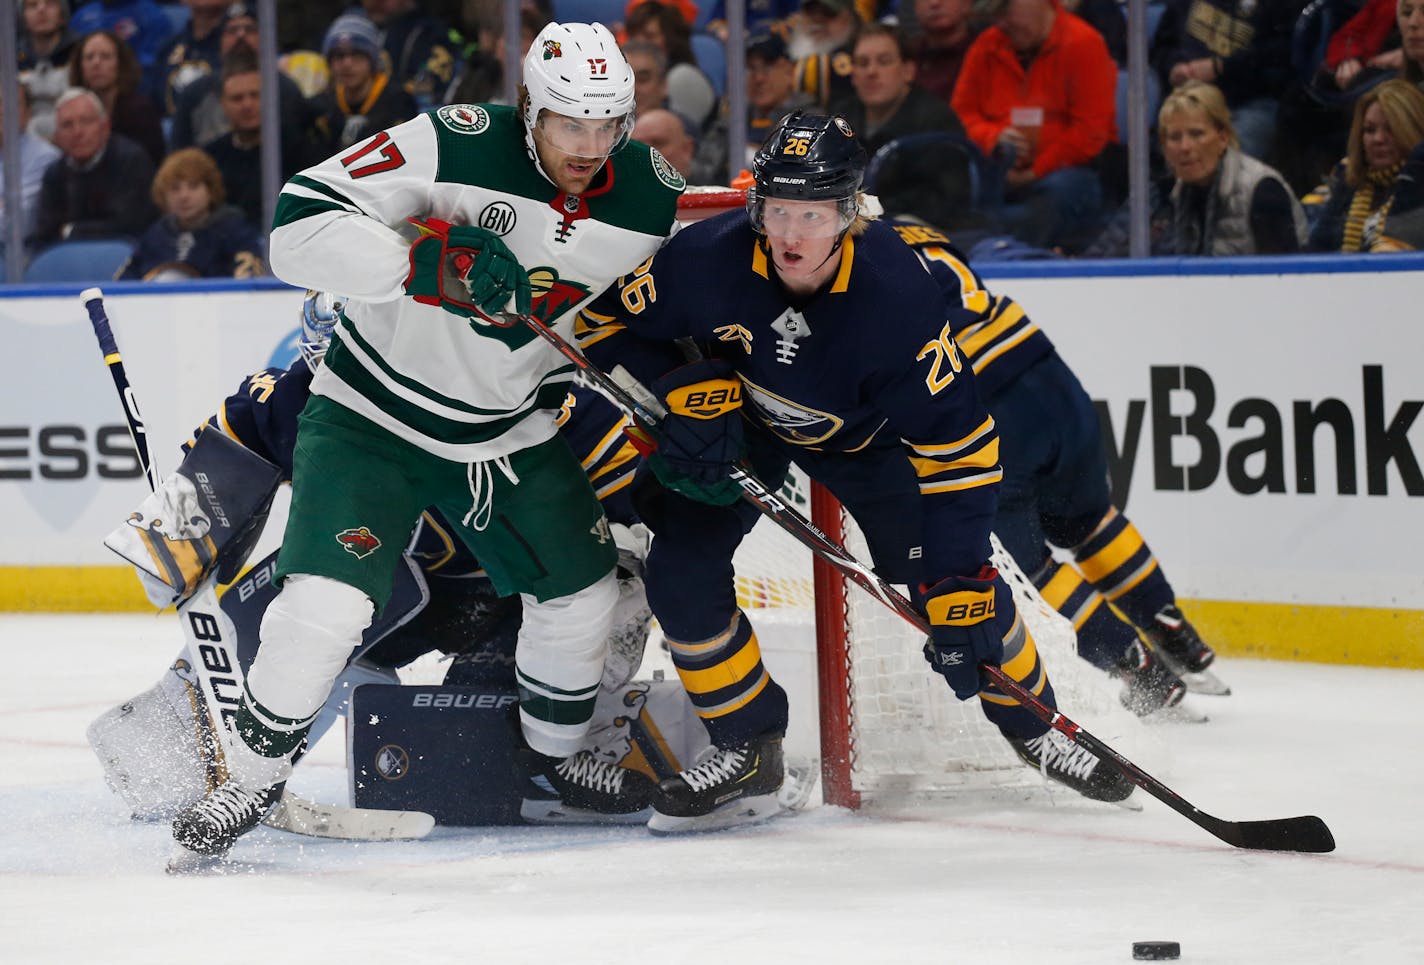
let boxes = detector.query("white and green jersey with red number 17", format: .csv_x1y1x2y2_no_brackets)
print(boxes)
271,104,684,461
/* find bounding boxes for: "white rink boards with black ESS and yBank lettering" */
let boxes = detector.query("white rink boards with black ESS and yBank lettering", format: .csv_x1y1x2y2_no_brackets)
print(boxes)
0,272,1424,609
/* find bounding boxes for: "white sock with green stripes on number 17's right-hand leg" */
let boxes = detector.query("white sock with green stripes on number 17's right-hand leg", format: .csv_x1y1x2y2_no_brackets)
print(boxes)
514,572,618,757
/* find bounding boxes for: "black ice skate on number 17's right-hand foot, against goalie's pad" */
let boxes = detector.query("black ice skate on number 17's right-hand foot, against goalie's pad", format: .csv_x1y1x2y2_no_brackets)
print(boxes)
520,750,654,824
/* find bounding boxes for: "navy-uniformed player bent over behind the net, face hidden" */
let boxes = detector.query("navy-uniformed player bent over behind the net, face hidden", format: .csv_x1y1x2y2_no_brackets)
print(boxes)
889,218,1226,714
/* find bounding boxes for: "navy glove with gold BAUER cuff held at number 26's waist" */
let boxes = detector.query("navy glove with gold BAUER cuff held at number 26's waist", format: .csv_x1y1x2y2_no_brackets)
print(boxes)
648,359,742,505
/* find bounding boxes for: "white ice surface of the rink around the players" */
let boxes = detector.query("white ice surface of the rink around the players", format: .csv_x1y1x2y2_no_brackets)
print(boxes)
0,615,1424,965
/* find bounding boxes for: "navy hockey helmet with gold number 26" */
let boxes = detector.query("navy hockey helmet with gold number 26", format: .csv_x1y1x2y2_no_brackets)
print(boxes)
746,111,869,233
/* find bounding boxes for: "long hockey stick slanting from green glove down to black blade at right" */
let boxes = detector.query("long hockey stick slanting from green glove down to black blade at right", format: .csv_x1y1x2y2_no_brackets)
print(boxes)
488,307,1334,854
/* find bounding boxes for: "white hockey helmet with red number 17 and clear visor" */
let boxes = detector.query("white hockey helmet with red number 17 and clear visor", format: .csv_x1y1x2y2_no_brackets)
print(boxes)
523,23,634,178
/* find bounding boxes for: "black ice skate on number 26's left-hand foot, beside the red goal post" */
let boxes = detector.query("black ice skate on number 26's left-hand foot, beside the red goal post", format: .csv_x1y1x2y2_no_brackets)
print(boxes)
648,734,786,834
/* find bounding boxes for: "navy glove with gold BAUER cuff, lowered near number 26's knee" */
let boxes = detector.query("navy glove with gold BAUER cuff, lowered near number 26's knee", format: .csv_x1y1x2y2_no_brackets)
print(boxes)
920,566,1004,700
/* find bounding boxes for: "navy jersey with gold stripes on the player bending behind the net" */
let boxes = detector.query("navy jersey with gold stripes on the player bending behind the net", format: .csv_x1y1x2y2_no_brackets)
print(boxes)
889,219,1054,399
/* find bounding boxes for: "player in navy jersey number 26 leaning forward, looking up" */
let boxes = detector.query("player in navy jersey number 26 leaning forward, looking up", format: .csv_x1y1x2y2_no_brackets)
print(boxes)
584,112,1132,833
